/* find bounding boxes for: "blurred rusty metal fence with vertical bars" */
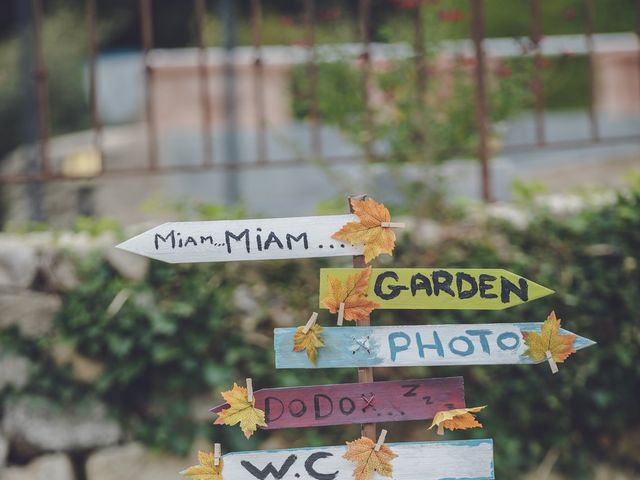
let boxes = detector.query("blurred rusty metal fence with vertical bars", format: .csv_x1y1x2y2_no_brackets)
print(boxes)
0,0,640,200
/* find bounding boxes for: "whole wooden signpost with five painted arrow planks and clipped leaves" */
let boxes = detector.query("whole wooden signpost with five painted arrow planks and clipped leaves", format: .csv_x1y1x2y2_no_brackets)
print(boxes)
119,197,594,480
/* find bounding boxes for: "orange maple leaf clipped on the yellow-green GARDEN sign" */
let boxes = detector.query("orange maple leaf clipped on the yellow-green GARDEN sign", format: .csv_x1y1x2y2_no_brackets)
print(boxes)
322,267,379,321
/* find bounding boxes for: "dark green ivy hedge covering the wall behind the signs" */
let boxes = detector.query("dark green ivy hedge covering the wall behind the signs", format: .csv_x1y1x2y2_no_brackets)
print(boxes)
2,185,640,479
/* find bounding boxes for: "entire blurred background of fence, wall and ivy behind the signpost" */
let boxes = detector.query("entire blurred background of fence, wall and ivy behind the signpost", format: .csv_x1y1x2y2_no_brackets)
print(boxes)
0,0,640,480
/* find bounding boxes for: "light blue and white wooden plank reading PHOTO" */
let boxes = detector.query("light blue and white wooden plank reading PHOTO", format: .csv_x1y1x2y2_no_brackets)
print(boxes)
274,323,595,368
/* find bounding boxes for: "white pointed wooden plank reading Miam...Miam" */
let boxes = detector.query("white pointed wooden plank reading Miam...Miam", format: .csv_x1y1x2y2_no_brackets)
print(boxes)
117,215,363,263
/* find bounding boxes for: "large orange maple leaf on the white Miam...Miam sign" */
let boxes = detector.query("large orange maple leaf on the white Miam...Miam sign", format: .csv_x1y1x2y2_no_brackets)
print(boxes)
331,198,396,263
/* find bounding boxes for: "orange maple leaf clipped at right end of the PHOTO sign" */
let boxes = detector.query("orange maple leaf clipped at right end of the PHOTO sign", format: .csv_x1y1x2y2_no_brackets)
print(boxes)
522,312,576,363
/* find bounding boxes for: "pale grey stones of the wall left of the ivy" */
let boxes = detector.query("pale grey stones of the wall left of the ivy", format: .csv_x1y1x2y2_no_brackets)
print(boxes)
0,233,164,480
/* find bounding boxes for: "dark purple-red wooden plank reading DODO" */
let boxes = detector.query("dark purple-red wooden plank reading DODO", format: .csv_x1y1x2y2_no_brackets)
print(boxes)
211,377,465,429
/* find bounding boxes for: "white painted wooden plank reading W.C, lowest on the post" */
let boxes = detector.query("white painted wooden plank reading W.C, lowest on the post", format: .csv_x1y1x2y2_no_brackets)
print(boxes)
208,439,495,480
